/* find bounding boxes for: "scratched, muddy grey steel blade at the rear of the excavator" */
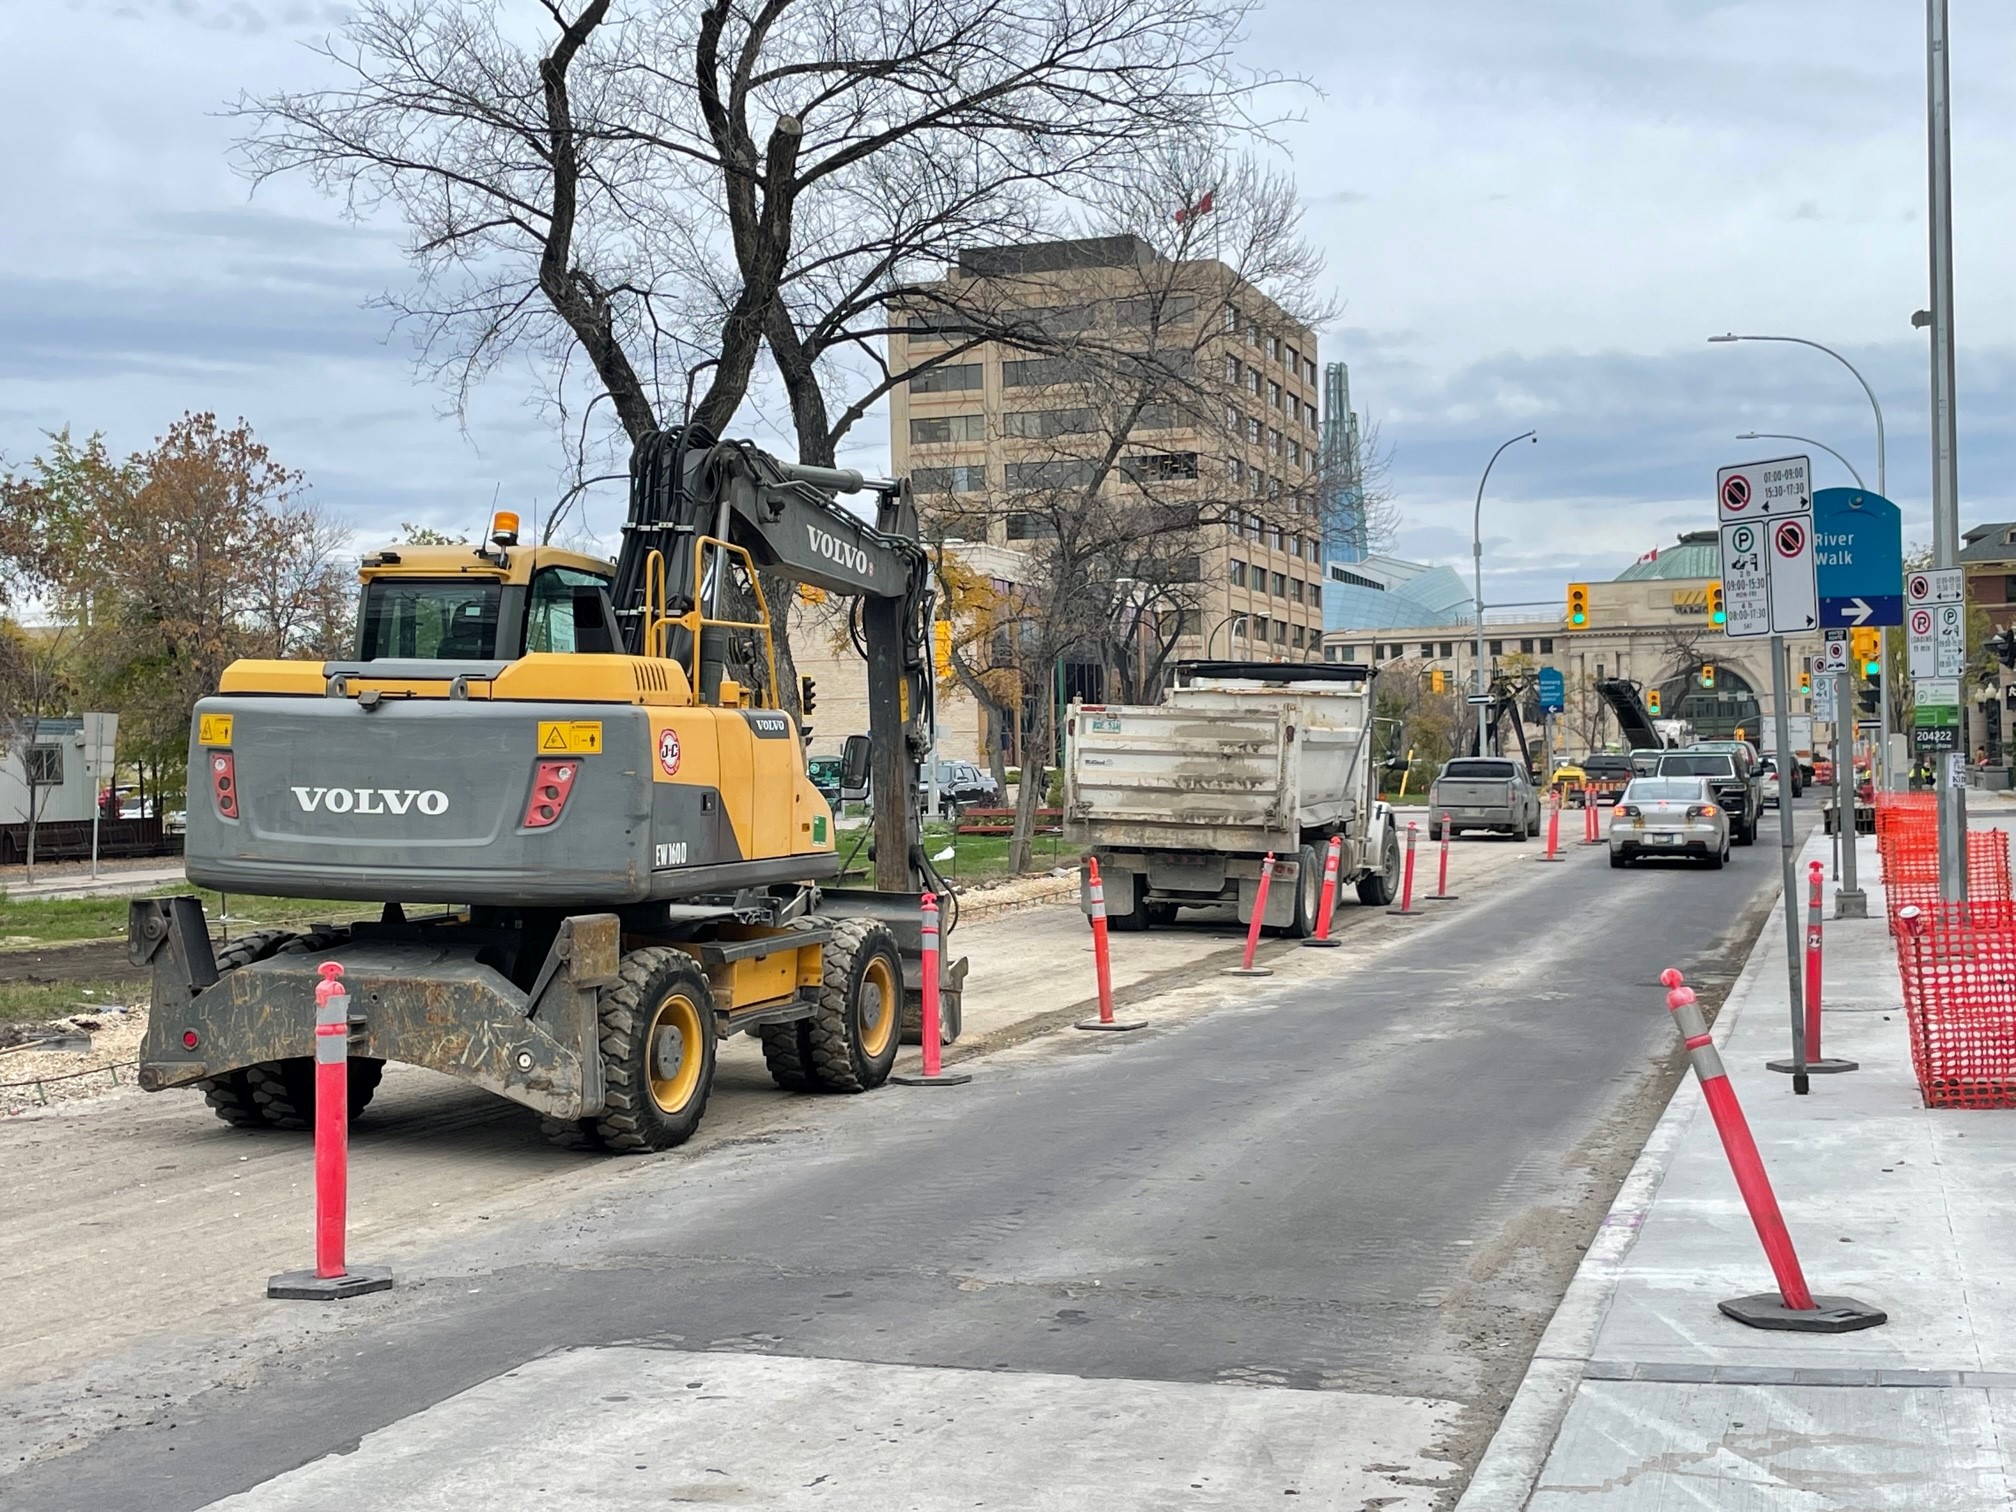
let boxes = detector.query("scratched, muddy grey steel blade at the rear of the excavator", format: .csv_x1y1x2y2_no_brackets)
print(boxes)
127,897,621,1119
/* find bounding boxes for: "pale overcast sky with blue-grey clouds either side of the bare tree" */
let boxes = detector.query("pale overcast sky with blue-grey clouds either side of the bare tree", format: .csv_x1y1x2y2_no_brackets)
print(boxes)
0,0,2016,603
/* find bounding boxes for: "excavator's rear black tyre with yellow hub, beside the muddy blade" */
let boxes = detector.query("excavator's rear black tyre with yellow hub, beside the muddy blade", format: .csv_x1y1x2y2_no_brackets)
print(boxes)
595,946,720,1153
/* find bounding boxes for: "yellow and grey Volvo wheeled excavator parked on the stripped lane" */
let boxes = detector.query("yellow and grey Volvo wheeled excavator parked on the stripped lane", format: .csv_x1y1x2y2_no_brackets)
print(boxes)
129,425,964,1151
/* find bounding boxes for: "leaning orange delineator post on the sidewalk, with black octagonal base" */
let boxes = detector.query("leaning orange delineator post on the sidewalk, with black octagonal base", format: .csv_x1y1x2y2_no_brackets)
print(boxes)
1659,968,1889,1333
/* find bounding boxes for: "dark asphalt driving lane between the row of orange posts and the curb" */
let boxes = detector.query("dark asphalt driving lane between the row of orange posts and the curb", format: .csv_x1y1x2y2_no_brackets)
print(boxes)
0,804,1810,1512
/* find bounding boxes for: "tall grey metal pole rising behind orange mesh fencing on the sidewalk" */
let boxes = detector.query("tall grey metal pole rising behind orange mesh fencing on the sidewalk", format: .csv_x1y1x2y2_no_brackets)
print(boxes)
1919,0,1968,903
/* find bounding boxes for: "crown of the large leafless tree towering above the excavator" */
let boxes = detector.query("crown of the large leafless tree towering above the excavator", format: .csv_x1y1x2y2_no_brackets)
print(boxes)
238,0,1256,717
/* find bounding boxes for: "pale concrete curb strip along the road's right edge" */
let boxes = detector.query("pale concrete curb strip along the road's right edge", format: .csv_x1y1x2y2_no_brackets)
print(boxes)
1454,883,1784,1512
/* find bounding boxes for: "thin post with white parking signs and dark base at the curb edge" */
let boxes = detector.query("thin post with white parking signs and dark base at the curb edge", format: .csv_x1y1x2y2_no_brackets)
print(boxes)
1716,458,1820,1095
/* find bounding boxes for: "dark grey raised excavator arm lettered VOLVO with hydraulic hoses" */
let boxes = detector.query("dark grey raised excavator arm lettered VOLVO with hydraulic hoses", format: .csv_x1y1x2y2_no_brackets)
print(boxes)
611,425,935,893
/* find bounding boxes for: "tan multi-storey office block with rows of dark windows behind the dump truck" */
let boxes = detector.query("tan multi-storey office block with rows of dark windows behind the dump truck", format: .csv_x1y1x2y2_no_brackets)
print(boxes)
889,236,1325,669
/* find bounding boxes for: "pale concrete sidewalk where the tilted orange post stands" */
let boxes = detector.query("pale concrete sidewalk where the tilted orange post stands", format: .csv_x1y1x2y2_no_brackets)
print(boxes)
1458,822,2016,1512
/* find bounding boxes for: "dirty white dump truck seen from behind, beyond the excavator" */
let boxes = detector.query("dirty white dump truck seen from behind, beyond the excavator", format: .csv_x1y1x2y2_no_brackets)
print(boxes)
1064,661,1401,937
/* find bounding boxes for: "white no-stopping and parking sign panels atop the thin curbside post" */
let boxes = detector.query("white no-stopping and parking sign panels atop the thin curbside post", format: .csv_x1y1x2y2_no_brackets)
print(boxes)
1716,458,1820,639
